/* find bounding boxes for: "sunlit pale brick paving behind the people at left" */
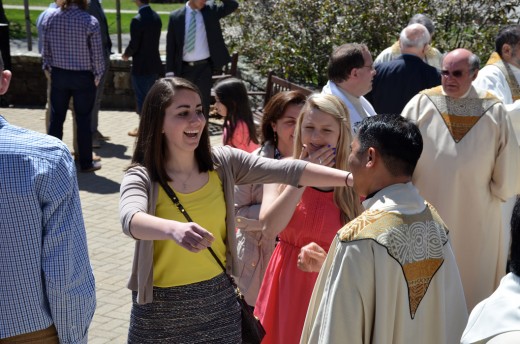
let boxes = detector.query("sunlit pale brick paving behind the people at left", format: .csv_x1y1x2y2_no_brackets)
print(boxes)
0,108,222,344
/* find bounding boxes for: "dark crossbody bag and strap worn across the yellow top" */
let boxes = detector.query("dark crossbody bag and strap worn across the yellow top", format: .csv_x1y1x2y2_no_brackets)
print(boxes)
160,183,265,344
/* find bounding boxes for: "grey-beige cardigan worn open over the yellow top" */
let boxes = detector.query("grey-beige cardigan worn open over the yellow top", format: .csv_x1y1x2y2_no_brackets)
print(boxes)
119,146,307,304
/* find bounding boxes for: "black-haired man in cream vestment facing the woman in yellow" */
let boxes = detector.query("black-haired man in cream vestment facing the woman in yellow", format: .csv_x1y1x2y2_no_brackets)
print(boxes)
301,115,468,344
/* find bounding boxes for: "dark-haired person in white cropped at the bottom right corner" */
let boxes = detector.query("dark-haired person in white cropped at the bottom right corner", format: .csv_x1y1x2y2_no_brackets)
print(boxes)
461,198,520,344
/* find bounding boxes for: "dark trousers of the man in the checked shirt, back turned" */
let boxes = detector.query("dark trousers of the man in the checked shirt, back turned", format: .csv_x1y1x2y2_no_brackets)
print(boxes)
49,67,96,169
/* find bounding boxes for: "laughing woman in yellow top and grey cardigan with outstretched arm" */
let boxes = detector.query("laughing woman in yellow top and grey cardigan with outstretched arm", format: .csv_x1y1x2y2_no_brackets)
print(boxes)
119,78,353,343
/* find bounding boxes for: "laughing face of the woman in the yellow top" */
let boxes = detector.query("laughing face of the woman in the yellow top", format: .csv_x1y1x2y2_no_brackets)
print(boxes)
163,89,206,153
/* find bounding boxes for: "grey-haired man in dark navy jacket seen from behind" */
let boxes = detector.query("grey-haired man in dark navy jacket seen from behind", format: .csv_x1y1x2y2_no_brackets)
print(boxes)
366,24,441,116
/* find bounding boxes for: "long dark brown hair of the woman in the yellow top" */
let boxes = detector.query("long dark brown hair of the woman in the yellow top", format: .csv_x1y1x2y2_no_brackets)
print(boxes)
130,77,213,183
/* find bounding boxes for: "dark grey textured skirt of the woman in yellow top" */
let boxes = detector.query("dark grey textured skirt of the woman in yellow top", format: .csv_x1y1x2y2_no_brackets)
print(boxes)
128,273,242,344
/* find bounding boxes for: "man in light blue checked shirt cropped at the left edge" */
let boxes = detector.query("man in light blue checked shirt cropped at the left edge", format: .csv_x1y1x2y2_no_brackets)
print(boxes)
0,52,96,343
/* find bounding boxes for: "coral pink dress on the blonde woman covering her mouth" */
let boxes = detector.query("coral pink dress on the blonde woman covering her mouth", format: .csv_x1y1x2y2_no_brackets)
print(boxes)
255,188,342,344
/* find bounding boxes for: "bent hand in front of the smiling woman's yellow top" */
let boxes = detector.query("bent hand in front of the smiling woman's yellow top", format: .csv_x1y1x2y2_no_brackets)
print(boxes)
171,222,215,253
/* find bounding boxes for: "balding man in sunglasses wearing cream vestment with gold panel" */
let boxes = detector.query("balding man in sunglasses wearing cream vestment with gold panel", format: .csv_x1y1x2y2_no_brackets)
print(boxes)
402,49,520,309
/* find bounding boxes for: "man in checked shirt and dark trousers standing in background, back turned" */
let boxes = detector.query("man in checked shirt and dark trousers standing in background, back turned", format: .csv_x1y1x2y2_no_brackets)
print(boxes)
42,0,105,172
